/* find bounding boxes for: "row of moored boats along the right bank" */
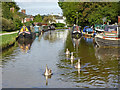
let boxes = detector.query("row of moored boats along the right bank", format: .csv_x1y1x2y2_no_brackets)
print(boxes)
71,25,120,47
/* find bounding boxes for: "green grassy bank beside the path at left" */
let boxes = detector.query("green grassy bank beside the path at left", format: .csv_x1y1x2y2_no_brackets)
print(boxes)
0,33,17,49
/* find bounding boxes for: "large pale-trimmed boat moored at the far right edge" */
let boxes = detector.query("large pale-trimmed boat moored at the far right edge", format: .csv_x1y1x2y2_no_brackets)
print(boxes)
95,25,120,47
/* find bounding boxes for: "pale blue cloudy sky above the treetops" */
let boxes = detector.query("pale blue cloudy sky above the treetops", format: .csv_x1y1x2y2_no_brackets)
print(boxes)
14,0,62,16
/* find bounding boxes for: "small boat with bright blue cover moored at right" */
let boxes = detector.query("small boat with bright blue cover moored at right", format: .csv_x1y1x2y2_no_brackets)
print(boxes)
82,26,96,37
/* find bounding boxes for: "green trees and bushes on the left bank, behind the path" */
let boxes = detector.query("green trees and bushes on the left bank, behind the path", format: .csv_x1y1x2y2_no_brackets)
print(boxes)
2,2,25,32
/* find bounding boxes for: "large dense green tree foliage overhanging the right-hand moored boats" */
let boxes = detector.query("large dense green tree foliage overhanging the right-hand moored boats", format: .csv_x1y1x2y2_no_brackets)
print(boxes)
58,2,120,26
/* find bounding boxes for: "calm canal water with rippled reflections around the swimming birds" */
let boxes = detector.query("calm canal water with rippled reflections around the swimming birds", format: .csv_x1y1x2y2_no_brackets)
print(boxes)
2,30,119,88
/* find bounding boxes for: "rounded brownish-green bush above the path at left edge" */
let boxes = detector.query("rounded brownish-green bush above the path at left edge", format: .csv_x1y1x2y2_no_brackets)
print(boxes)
2,18,15,31
